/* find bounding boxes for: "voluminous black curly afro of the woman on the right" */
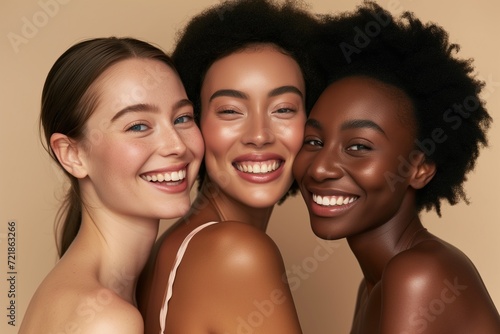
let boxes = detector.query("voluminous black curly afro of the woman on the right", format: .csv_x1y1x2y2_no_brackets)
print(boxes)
311,1,492,215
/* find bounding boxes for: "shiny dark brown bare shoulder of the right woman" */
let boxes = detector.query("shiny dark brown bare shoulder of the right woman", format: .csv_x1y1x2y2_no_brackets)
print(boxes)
381,239,500,333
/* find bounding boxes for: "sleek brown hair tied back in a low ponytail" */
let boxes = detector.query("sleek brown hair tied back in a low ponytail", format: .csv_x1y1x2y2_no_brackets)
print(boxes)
40,37,174,257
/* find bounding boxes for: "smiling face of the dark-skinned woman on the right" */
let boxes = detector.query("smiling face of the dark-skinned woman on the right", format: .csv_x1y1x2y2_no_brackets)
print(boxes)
293,77,422,239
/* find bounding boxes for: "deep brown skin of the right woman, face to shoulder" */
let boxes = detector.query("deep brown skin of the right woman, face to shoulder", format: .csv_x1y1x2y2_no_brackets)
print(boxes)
294,77,500,334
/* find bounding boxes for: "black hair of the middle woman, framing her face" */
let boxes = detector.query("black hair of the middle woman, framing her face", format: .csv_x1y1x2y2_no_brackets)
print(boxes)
172,0,324,203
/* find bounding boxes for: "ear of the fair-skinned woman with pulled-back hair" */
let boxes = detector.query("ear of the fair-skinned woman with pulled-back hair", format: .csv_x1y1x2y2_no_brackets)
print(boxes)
50,133,87,179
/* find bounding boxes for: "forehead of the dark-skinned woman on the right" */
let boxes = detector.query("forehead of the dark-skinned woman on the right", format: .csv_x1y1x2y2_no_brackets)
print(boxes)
311,76,416,128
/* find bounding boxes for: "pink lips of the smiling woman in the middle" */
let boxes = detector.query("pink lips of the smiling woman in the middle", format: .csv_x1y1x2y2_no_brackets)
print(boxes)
232,153,285,183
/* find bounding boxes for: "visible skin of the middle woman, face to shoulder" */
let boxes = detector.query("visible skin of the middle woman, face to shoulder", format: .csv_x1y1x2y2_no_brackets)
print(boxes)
138,45,305,334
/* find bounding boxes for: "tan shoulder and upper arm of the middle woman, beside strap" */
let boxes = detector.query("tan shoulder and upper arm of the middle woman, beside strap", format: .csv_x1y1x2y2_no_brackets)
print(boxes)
167,222,301,334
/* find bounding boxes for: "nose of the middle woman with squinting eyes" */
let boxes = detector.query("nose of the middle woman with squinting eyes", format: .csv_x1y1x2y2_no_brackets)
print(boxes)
241,110,275,147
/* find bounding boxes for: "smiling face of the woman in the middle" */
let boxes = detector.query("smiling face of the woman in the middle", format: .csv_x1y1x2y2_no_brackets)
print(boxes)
200,46,306,208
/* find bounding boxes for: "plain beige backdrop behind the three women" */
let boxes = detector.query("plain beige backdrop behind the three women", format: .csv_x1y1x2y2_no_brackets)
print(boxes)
0,0,500,334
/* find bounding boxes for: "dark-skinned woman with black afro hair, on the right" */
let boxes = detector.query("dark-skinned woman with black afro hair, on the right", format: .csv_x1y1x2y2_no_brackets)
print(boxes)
293,2,500,334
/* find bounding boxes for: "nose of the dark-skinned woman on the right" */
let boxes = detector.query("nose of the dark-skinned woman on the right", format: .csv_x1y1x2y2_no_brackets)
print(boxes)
309,148,344,182
